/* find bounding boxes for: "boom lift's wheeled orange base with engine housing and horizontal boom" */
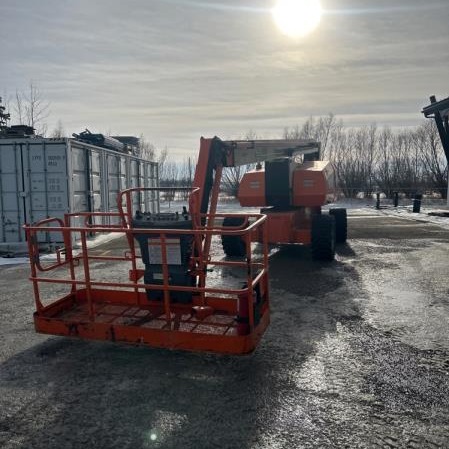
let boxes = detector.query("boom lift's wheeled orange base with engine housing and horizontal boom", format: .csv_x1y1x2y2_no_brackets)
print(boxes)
203,139,347,260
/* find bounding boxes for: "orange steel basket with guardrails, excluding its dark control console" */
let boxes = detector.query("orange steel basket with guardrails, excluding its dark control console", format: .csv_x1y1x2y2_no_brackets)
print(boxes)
25,185,270,354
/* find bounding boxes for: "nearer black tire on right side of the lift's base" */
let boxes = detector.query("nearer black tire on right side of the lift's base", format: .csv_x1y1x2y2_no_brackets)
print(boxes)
312,214,335,260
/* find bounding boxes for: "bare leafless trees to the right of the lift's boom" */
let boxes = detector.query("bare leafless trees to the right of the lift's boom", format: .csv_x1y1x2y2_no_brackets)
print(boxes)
283,114,448,198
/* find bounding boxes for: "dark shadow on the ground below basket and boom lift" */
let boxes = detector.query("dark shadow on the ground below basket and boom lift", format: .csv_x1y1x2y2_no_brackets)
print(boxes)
0,246,360,449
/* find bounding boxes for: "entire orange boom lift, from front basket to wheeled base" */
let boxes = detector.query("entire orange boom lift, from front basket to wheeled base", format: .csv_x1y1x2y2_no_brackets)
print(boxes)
25,137,344,354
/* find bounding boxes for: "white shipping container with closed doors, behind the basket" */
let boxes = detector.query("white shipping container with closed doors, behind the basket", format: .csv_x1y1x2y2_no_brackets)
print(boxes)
0,138,159,248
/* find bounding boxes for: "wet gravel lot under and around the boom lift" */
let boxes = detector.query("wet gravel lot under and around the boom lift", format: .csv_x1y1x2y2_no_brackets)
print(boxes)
0,209,449,449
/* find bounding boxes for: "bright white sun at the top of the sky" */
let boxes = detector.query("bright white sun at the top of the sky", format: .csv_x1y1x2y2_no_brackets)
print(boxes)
271,0,322,37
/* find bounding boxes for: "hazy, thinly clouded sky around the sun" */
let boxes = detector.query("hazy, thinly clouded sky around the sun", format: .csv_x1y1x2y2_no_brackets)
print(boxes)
0,0,449,158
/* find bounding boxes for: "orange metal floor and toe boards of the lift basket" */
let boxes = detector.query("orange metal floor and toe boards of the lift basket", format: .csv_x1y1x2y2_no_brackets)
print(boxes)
34,290,269,354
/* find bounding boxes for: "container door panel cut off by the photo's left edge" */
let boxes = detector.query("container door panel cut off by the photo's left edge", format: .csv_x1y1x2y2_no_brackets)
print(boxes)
0,143,28,243
